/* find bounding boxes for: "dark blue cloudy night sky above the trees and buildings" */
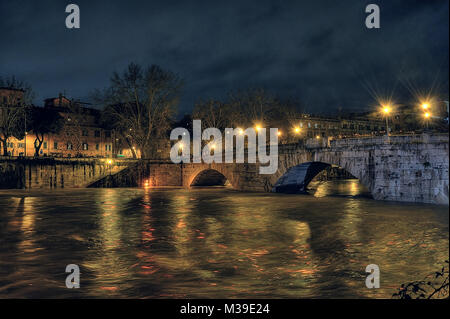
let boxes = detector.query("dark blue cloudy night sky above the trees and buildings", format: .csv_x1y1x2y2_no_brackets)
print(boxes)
0,0,449,115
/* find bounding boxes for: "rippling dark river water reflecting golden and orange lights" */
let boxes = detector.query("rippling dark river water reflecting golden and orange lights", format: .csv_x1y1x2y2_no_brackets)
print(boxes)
0,180,449,298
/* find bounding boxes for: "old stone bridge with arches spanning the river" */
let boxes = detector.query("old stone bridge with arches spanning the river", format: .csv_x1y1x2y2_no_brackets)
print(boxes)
90,135,449,205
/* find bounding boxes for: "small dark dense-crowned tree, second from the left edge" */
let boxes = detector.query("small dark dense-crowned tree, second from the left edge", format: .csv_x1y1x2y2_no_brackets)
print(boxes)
31,107,64,157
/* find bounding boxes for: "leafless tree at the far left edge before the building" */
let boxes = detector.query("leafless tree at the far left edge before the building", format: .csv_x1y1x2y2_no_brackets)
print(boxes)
0,77,33,156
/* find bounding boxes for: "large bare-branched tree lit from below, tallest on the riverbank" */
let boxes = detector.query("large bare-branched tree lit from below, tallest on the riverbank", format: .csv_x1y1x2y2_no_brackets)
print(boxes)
94,63,183,158
